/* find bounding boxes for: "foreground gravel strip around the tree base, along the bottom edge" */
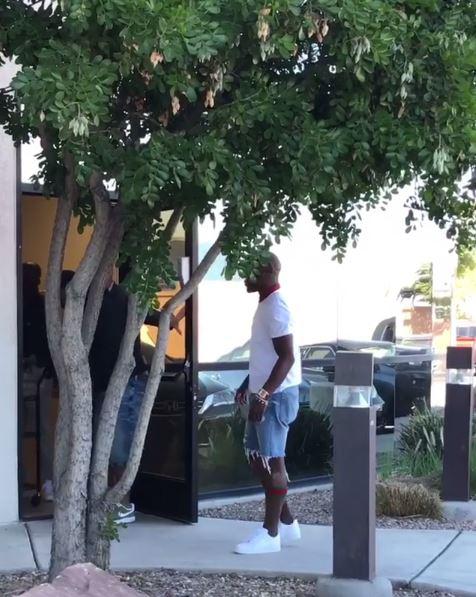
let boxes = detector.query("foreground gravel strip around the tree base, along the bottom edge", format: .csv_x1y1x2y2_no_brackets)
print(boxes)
0,570,454,597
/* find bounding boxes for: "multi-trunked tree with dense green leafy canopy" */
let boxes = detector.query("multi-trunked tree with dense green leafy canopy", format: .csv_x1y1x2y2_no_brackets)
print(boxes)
0,0,475,574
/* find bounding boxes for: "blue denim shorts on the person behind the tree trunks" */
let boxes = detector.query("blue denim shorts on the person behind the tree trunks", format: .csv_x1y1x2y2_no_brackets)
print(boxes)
110,375,147,468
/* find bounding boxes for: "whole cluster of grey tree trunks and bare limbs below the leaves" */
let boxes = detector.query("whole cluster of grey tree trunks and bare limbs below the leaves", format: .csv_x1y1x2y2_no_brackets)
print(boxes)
49,185,226,577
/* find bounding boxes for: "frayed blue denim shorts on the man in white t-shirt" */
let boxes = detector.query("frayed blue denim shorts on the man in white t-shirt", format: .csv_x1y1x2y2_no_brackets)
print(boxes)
244,386,299,460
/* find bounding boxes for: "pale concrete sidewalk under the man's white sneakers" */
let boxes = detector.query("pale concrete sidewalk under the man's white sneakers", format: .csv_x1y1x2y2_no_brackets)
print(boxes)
0,516,476,596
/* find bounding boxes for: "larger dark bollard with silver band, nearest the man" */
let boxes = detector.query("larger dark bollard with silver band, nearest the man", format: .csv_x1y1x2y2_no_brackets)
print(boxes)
333,352,376,581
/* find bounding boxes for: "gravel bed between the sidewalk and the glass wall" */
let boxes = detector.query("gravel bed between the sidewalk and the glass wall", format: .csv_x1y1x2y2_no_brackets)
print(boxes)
200,489,476,531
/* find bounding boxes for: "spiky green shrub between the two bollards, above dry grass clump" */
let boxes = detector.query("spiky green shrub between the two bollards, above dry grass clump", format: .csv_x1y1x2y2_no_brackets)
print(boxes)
399,408,444,462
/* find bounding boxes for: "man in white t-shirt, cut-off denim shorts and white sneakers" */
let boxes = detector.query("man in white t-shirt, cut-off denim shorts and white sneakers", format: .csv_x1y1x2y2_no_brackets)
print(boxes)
235,254,301,554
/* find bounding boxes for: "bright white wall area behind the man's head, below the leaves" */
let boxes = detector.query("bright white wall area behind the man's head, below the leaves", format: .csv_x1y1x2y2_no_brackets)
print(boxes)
199,193,452,362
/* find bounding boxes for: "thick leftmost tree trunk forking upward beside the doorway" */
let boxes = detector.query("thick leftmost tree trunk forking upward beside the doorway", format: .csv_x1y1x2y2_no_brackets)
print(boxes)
49,172,110,578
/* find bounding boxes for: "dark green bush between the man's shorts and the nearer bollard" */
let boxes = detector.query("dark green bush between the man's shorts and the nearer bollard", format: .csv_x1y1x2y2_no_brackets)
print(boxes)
286,408,333,474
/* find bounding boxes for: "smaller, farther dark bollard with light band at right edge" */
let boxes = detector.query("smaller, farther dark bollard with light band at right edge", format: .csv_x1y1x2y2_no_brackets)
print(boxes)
442,346,474,502
